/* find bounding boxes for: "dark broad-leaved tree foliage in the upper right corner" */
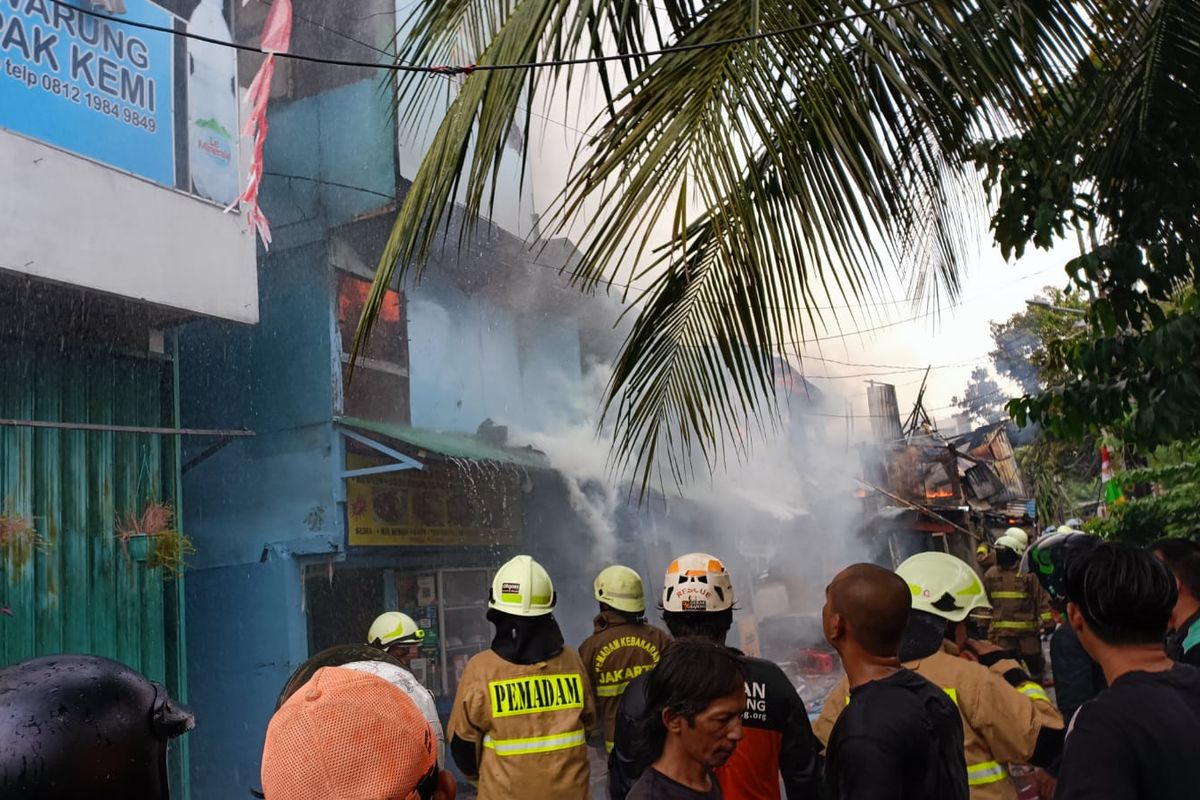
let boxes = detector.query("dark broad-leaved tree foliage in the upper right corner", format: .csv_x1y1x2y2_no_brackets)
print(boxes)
980,0,1200,450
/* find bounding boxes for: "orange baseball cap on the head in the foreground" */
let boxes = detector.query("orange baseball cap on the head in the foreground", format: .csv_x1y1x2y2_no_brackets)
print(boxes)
262,667,437,800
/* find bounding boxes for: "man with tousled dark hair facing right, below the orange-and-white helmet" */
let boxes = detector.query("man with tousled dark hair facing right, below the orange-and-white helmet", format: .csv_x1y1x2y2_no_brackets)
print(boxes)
626,639,746,800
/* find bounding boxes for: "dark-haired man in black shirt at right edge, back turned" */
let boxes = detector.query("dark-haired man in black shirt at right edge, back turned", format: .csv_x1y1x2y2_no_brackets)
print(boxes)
1055,542,1200,800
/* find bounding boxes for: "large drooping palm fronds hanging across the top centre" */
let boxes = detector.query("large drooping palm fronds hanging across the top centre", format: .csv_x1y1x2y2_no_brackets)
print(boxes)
359,0,1108,487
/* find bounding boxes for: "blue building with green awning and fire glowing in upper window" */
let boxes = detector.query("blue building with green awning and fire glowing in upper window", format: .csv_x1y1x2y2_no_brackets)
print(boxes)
179,40,643,800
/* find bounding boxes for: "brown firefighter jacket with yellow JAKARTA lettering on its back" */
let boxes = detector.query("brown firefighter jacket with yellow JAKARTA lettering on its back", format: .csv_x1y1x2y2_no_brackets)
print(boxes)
580,609,671,752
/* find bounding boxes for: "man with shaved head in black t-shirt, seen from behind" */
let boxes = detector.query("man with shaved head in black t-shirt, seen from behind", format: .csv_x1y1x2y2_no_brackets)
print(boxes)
821,564,968,800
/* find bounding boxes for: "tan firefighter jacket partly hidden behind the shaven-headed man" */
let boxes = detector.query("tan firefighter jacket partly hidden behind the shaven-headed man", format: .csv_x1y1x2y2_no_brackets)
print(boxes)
812,649,1063,800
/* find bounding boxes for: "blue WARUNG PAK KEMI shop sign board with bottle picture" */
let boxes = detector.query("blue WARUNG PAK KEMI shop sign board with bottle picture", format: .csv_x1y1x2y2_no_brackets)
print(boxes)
0,0,240,205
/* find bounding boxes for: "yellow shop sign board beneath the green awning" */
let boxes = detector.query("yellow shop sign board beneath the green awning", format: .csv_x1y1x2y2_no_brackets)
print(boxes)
346,453,522,547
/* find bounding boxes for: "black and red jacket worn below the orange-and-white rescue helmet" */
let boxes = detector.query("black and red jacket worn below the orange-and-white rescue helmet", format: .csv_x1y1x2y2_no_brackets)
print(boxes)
608,658,822,800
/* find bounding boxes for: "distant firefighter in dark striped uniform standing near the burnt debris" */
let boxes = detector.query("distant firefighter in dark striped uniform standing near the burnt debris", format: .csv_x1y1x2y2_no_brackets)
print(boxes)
983,528,1054,681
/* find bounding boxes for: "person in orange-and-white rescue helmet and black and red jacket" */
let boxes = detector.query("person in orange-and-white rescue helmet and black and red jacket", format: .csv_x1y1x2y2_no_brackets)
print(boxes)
608,553,821,800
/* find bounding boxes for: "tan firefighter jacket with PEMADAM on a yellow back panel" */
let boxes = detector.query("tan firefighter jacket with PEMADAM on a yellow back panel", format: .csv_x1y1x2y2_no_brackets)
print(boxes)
449,648,595,800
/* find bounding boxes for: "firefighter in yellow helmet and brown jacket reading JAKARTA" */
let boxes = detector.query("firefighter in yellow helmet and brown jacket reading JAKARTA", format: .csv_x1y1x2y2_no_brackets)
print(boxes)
580,565,670,752
